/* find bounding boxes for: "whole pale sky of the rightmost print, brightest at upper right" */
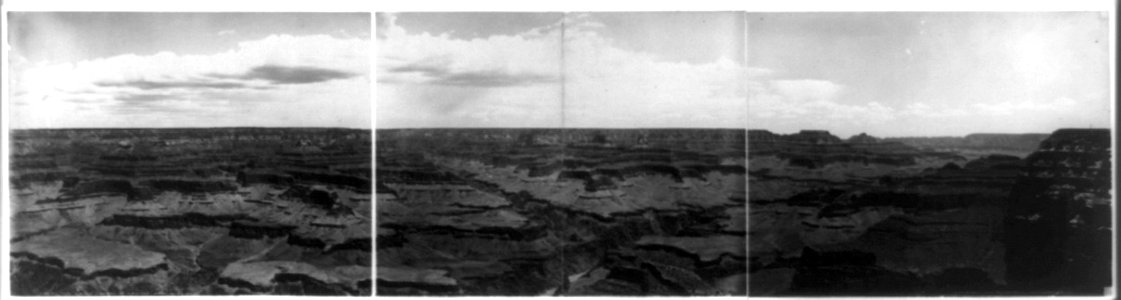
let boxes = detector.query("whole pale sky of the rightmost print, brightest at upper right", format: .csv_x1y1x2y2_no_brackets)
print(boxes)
748,12,1112,138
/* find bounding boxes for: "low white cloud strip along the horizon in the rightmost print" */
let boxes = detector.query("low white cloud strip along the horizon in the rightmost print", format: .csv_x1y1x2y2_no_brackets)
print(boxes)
748,65,1099,137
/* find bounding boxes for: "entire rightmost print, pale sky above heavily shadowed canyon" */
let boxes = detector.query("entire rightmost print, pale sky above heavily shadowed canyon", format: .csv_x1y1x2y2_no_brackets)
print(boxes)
748,12,1114,296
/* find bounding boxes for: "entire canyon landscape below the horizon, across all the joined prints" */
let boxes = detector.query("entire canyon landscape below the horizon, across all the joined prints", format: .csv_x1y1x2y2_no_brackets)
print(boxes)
9,128,1113,297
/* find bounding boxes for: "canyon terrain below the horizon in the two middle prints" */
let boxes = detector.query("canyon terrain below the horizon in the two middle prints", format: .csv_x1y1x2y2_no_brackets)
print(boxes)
376,129,747,296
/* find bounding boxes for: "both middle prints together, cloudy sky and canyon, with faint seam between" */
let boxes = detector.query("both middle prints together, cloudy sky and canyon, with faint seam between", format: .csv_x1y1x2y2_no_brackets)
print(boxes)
376,12,748,296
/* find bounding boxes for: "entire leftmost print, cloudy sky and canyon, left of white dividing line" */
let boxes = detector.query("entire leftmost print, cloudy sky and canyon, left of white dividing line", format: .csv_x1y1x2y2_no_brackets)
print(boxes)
4,12,372,296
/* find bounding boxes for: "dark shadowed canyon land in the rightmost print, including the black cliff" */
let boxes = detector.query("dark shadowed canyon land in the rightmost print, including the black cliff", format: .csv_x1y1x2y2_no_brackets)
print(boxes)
748,129,1113,296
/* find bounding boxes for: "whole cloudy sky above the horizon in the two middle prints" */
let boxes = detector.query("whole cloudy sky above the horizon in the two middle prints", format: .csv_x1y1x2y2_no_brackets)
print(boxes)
376,12,747,128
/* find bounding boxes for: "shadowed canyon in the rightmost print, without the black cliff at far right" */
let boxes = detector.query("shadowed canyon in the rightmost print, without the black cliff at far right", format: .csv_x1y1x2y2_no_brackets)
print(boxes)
748,131,1044,296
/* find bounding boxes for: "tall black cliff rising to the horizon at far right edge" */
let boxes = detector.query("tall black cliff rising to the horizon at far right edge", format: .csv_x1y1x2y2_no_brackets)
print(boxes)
1006,129,1113,294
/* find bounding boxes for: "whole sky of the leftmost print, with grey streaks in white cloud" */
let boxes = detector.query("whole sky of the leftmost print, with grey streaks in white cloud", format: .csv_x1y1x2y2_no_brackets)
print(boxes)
8,12,372,129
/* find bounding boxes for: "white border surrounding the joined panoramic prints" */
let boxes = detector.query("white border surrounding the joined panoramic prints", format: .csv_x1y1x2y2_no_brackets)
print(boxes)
0,0,1119,299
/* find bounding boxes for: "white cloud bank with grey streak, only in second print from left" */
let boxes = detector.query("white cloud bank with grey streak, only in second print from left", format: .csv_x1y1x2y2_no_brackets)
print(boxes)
377,13,562,128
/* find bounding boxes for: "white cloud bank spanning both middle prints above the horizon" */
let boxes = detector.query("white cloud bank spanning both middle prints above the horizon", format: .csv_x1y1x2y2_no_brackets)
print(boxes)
377,13,747,128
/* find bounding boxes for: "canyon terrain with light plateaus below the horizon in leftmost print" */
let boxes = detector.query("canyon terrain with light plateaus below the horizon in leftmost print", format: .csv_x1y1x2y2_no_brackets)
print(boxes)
11,128,373,296
